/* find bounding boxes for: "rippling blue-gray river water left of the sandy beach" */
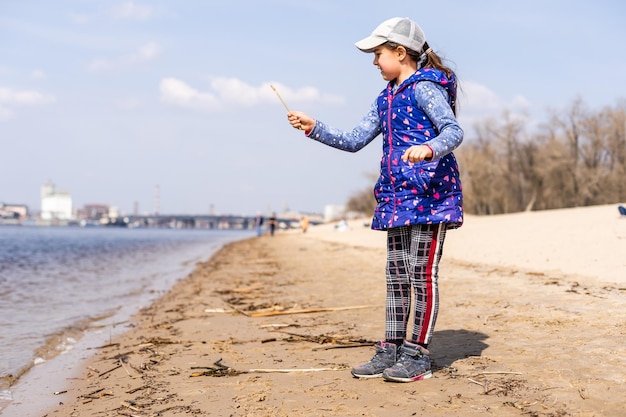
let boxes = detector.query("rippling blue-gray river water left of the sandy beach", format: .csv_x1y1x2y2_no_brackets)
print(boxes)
0,226,253,413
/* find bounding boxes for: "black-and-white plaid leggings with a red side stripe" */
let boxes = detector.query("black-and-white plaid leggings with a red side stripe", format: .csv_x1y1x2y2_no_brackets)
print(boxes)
385,223,447,346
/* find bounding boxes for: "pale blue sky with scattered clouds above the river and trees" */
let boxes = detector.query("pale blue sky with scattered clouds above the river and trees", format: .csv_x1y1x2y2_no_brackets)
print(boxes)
0,0,626,214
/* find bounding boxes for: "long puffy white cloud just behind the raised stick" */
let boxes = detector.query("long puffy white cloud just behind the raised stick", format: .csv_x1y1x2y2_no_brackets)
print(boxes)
159,78,344,111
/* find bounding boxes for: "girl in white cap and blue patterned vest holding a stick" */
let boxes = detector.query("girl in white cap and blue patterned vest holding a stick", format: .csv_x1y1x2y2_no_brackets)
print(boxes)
287,17,463,382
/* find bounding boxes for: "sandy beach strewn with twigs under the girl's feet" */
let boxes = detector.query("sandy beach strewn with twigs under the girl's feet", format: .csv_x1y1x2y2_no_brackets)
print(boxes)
2,205,626,417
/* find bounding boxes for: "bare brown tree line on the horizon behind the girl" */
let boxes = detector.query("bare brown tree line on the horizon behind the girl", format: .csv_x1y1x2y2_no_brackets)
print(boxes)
346,99,626,215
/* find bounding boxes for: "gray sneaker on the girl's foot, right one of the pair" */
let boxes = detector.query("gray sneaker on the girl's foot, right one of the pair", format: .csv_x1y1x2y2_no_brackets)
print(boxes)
383,342,433,382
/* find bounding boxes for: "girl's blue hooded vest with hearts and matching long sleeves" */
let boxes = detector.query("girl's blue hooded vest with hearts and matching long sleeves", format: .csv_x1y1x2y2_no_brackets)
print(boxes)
308,68,463,230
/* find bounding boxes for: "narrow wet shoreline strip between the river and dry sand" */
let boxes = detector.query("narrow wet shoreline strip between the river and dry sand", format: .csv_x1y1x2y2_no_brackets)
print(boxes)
0,231,253,415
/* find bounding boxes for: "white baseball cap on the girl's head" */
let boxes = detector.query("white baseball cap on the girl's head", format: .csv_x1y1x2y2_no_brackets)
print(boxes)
355,17,426,52
